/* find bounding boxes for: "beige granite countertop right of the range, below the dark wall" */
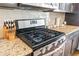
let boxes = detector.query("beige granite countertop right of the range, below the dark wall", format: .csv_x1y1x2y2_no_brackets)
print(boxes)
52,25,79,35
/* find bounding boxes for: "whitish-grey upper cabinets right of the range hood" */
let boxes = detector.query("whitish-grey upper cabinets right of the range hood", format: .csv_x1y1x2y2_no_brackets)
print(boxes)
52,3,74,13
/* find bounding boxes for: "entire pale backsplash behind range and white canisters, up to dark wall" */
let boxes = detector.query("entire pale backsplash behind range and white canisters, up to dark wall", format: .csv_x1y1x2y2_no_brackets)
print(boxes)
0,9,65,38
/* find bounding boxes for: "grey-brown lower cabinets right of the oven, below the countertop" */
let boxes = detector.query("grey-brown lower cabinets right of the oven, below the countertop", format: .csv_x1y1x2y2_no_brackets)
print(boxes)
64,31,79,56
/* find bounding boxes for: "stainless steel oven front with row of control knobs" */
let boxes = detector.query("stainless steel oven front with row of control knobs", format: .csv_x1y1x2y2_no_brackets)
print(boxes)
33,35,65,56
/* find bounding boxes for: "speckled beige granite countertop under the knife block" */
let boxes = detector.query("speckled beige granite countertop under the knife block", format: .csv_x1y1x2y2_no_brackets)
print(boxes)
0,38,32,56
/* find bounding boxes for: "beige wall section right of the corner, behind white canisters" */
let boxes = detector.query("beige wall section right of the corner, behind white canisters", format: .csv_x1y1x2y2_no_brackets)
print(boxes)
48,12,65,26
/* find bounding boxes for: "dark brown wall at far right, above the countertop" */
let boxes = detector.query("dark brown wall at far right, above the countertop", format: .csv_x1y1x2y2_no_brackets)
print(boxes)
65,11,79,26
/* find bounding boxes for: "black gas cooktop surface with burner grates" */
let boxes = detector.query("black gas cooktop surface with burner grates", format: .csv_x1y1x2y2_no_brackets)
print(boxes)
17,28,64,50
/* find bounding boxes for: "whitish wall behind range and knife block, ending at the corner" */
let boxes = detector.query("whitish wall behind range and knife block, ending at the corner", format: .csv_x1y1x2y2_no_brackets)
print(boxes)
0,9,48,38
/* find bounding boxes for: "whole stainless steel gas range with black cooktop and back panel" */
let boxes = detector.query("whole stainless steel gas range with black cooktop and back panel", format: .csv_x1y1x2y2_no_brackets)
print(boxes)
16,18,65,56
